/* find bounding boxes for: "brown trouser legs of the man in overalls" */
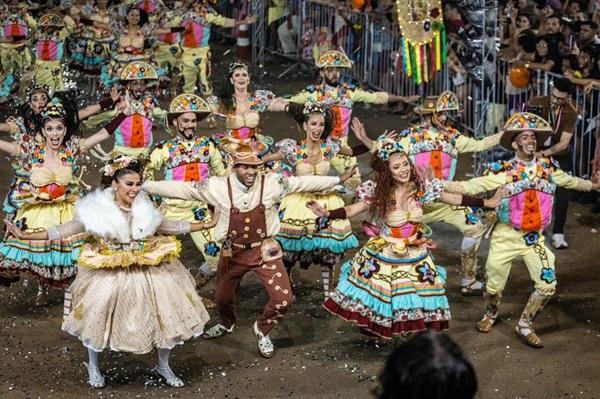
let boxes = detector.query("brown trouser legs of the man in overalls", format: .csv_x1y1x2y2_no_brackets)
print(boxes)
215,248,292,335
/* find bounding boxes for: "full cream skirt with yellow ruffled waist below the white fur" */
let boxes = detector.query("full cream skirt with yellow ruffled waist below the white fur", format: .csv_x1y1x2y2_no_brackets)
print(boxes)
62,237,209,354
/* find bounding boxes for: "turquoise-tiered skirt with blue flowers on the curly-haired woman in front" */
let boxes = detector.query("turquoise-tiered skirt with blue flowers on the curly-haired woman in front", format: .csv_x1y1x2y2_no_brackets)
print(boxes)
323,237,451,339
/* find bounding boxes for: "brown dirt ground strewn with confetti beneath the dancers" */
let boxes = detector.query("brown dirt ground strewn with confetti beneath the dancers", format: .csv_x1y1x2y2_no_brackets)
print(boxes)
0,46,600,399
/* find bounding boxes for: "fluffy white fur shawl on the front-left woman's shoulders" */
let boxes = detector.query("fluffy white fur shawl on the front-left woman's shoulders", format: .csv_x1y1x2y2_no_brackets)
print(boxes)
75,188,163,242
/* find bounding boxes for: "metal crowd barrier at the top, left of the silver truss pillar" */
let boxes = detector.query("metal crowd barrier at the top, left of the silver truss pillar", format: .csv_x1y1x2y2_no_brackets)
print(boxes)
252,0,448,96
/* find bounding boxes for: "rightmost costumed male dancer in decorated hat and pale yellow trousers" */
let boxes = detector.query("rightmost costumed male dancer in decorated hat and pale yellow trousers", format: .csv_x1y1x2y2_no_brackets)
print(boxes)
444,112,600,348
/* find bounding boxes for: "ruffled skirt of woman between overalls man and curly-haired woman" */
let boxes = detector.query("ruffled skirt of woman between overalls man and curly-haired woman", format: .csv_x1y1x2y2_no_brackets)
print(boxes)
277,193,358,267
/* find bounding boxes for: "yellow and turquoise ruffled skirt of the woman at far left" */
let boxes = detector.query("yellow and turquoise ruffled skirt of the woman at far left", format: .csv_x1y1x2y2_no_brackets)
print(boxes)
0,202,87,288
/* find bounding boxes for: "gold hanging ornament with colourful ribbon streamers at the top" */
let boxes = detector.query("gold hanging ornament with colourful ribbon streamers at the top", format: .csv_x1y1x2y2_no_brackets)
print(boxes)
396,0,446,84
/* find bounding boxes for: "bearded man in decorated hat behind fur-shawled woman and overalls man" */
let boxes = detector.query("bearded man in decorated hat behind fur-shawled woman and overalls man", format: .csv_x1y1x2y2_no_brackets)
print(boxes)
146,94,227,308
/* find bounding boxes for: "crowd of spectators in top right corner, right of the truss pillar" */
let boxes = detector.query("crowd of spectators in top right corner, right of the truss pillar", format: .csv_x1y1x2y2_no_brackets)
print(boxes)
499,0,600,92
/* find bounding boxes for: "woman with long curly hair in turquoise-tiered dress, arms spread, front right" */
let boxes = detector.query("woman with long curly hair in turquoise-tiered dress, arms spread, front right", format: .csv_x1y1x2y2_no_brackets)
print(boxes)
307,131,499,339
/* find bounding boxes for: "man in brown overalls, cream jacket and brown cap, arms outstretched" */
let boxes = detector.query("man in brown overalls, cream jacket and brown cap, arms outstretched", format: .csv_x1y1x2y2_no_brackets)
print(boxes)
144,145,354,358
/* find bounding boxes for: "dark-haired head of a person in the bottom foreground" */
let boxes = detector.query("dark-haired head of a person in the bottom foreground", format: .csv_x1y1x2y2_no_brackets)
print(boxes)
377,332,477,399
